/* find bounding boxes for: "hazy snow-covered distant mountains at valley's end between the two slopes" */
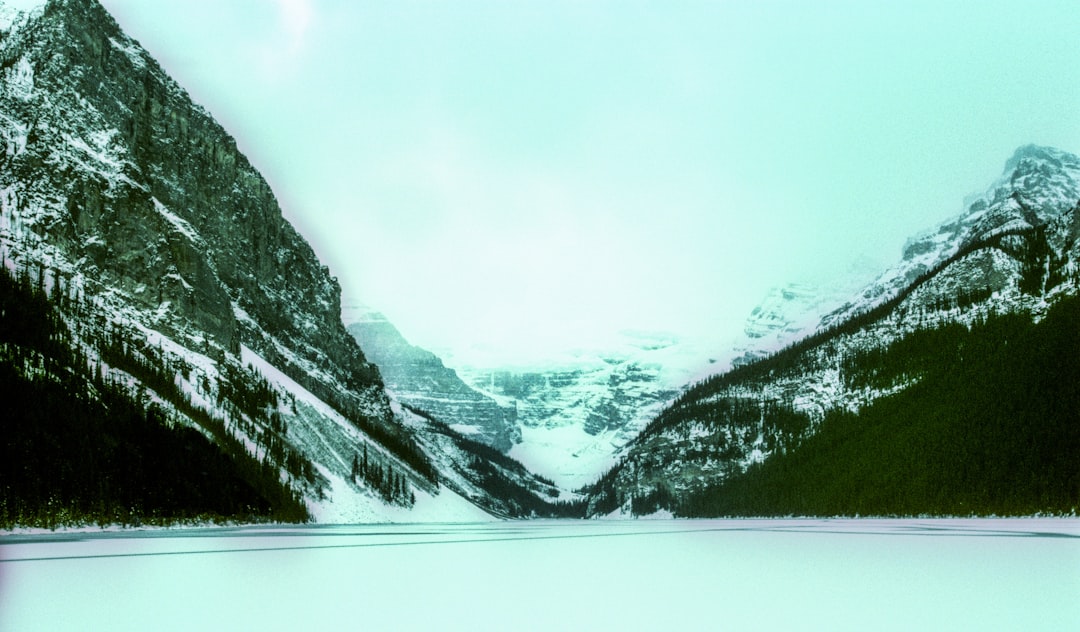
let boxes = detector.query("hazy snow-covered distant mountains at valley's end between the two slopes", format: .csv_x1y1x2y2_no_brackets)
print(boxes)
346,307,703,492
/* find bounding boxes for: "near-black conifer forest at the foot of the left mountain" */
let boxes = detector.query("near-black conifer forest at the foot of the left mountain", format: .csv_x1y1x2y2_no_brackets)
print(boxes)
0,269,311,528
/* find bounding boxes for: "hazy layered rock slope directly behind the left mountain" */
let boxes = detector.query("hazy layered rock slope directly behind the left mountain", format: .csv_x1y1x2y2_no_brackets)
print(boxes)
348,311,522,453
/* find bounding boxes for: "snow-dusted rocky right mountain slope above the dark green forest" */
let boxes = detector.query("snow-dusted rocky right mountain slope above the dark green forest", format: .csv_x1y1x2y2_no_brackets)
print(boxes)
591,146,1080,513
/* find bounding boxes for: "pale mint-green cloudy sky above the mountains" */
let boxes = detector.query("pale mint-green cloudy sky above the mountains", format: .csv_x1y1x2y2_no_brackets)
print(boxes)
95,0,1080,363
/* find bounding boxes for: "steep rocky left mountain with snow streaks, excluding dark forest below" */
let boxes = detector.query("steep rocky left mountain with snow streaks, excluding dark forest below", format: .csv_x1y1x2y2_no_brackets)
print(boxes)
0,0,496,522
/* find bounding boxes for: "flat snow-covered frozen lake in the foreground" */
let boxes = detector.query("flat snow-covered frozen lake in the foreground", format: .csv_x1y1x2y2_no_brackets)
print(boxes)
0,519,1080,631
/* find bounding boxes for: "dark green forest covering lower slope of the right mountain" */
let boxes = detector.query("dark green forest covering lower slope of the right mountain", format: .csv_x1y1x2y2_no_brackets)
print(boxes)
676,297,1080,516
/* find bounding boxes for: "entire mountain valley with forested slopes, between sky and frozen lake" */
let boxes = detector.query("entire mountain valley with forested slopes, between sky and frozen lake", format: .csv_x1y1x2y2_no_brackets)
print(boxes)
0,0,1080,528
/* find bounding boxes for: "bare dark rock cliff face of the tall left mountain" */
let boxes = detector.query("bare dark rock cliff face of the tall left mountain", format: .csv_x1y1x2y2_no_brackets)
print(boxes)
0,0,389,417
